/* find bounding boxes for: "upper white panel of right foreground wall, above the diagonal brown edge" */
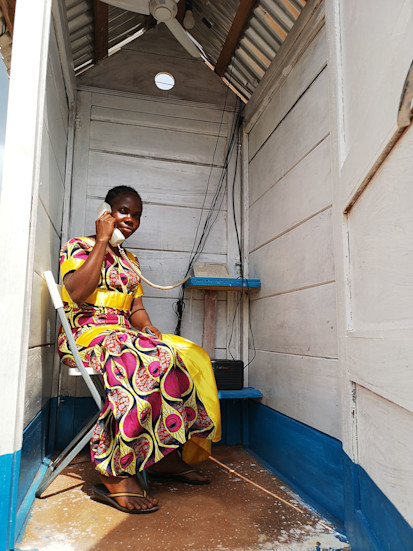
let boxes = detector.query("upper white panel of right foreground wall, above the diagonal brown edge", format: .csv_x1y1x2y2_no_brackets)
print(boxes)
339,0,413,202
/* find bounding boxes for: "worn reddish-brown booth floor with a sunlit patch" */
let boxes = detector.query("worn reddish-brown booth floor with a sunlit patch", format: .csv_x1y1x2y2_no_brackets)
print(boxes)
16,446,350,551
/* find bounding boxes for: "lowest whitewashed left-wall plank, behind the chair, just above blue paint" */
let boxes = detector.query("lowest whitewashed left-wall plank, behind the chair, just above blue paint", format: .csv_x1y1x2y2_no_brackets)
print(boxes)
24,345,54,426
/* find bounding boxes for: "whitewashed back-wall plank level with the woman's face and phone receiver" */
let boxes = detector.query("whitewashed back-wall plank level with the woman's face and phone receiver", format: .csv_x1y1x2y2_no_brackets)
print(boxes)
85,199,227,256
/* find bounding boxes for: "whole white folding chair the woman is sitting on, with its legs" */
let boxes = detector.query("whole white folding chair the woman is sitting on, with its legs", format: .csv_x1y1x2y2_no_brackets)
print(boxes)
36,271,104,497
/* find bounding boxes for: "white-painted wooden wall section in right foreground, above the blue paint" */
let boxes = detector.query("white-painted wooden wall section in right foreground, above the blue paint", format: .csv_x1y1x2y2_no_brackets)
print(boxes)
326,0,413,526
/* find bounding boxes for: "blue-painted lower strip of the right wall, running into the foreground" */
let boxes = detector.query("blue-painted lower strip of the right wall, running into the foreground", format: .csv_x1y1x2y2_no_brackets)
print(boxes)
248,400,413,551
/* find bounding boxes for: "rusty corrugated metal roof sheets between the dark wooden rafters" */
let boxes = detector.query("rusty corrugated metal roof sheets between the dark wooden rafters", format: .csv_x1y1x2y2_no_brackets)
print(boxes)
66,0,306,100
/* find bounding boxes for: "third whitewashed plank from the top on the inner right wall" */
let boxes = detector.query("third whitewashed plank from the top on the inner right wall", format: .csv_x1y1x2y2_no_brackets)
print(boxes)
250,138,332,251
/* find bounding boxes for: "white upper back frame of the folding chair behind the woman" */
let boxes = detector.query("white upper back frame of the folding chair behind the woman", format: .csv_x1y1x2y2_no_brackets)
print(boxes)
43,270,102,408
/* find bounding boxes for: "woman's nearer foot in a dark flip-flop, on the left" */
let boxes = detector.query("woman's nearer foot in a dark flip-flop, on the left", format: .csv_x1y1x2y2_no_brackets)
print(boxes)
100,475,158,512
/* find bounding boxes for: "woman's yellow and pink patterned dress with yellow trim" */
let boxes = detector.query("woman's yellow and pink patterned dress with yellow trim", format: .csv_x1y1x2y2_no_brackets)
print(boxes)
58,237,220,476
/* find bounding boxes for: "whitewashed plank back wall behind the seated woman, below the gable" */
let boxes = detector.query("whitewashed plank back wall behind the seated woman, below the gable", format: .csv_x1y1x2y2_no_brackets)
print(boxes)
69,89,240,396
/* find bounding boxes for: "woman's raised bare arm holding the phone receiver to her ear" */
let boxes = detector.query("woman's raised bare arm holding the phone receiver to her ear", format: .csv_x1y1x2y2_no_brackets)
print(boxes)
63,212,115,305
